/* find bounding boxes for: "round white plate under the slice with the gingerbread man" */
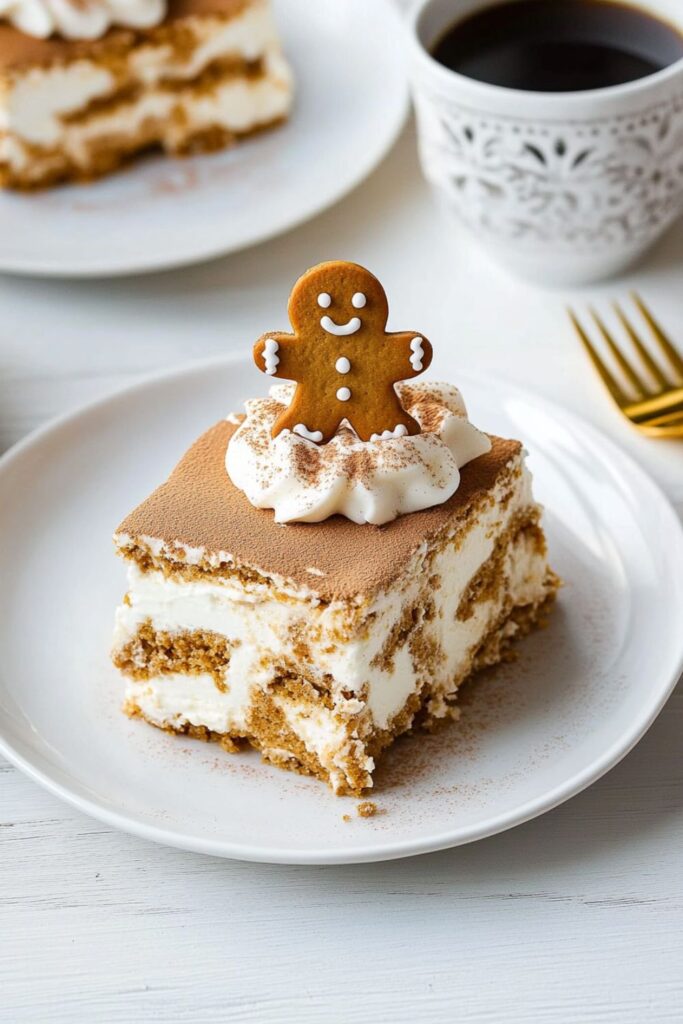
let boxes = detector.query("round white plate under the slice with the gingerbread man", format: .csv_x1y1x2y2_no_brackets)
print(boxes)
0,359,683,863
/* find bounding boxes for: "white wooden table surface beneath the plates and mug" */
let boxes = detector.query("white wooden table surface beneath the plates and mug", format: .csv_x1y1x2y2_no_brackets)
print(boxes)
0,121,683,1024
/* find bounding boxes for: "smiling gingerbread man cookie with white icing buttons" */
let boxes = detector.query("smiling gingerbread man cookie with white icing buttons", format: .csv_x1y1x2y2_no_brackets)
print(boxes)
254,260,432,444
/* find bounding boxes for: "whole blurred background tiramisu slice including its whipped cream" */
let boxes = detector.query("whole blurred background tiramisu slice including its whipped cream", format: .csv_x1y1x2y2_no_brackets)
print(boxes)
0,0,292,188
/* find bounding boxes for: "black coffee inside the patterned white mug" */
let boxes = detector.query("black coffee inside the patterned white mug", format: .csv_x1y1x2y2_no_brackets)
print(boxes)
432,0,683,92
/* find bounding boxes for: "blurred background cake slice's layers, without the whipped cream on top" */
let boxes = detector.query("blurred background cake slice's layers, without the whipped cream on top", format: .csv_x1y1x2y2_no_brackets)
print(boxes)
0,0,292,187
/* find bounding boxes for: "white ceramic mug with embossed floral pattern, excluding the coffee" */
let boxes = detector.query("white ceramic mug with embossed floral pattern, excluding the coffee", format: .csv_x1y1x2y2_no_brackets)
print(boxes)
411,0,683,285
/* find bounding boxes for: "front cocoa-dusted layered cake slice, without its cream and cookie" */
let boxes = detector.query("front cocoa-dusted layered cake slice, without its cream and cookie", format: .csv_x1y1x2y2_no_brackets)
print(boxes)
114,423,557,794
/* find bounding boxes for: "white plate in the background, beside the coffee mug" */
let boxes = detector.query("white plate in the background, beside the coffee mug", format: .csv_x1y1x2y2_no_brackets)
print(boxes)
0,0,408,276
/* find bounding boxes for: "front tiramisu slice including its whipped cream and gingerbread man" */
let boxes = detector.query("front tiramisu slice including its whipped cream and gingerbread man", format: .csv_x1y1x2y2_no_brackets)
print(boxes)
114,264,557,795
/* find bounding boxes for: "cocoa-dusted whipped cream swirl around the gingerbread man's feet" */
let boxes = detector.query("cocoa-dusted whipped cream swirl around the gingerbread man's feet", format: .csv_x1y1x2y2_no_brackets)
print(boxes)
225,383,490,525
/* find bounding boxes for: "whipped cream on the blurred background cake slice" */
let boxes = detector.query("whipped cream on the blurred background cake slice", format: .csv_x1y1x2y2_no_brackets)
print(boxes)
0,0,166,39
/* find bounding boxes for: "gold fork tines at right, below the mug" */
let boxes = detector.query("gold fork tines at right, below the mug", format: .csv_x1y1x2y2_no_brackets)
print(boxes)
567,292,683,437
